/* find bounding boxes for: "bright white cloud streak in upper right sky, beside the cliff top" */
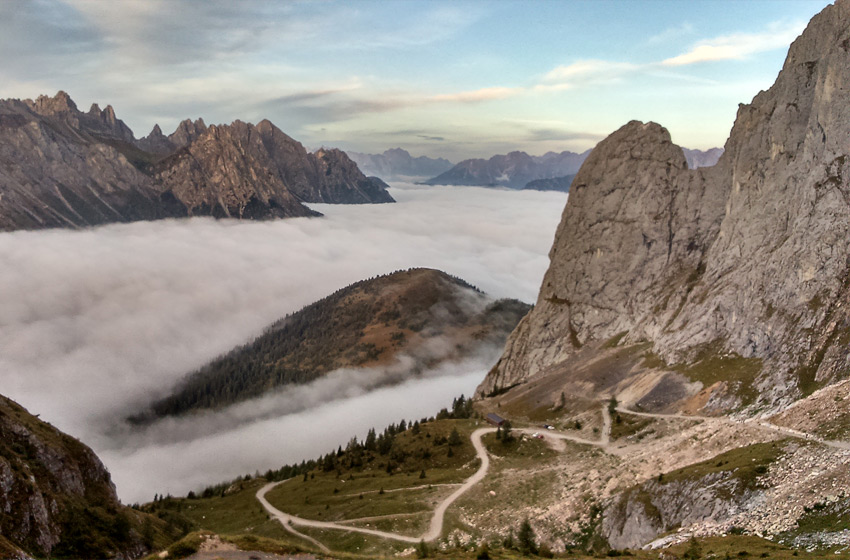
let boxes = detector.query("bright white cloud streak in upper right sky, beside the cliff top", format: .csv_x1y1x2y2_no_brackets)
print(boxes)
661,22,806,66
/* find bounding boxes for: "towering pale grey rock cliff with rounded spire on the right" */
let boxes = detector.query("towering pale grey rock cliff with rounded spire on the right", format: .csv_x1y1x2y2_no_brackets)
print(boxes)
479,0,850,412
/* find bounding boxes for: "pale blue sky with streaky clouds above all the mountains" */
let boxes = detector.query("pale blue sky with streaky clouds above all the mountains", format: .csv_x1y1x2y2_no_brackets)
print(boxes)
0,0,827,162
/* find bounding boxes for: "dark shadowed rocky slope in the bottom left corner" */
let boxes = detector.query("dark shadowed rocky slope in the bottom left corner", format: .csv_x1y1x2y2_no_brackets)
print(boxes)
0,396,153,558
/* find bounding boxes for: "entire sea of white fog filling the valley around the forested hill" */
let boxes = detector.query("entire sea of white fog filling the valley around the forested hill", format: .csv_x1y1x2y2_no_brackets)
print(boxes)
0,184,566,502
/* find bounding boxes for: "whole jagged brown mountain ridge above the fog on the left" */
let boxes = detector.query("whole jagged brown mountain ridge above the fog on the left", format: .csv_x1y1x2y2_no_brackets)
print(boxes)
0,92,393,231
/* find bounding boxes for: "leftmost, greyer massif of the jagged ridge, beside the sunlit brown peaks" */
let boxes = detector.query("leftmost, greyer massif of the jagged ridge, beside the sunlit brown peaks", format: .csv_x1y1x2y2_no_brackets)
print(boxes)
0,92,179,230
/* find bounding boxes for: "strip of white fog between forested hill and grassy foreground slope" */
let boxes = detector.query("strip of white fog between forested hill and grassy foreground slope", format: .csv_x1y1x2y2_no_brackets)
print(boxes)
100,353,498,502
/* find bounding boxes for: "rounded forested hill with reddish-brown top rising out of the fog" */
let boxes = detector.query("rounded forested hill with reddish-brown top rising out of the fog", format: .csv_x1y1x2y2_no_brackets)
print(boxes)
135,269,529,422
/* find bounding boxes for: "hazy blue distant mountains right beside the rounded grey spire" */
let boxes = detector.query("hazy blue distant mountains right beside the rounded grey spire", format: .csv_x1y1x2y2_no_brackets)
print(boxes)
425,150,590,189
